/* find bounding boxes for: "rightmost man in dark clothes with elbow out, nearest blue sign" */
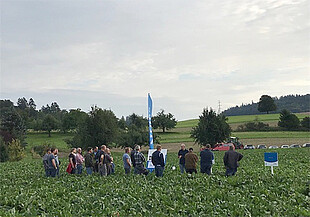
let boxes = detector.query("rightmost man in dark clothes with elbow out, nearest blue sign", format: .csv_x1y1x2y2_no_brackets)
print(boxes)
223,146,243,176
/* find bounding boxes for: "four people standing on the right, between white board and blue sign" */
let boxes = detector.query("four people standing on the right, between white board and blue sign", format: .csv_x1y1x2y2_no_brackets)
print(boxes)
178,144,243,176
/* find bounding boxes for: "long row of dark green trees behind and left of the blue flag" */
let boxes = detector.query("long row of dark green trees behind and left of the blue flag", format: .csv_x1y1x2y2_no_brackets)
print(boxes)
0,97,177,162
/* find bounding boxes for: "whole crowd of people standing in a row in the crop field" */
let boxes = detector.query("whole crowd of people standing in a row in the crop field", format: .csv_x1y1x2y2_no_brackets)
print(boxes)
43,144,243,177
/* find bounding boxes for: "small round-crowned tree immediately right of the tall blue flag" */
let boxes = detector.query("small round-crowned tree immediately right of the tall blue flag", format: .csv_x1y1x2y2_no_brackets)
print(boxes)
152,109,177,133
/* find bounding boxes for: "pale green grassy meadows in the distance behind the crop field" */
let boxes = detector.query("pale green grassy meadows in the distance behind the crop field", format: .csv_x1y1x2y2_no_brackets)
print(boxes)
26,113,310,151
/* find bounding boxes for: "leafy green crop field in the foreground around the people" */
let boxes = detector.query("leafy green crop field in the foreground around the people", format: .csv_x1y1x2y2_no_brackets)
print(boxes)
0,148,310,216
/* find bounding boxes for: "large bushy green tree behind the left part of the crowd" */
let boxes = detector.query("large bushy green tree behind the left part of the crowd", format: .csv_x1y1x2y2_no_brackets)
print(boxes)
66,107,119,148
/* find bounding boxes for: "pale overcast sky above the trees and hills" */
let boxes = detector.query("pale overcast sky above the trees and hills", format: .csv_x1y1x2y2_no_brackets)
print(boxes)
1,0,310,120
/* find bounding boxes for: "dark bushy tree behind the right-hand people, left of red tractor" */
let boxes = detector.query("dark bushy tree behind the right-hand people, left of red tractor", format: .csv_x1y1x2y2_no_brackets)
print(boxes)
191,108,231,147
